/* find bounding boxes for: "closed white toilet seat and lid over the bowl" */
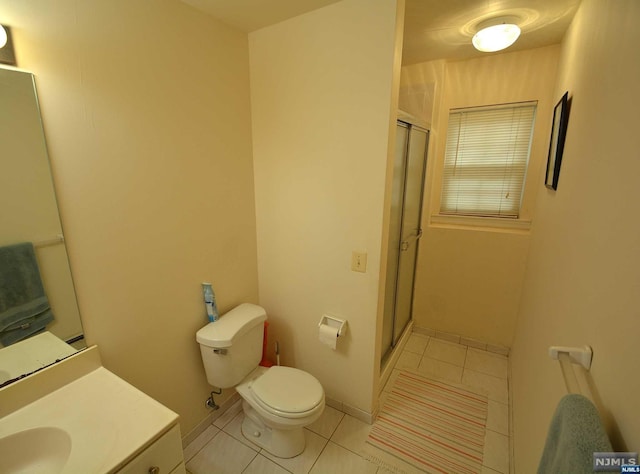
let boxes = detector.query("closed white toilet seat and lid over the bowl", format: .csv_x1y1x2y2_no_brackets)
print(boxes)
249,366,324,418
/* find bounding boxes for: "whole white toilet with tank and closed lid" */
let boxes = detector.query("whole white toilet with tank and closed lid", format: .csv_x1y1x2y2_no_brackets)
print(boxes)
196,303,325,458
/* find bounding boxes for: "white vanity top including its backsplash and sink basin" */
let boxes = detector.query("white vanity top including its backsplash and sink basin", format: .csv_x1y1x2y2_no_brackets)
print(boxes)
0,352,184,474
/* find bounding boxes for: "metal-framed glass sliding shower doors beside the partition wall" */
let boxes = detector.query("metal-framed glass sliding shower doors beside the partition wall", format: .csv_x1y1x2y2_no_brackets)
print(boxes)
380,116,429,365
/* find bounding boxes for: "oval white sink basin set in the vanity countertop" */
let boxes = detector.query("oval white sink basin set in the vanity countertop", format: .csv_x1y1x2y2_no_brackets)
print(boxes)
0,427,71,474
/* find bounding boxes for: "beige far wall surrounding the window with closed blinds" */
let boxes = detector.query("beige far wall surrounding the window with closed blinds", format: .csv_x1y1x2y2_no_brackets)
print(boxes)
410,46,558,346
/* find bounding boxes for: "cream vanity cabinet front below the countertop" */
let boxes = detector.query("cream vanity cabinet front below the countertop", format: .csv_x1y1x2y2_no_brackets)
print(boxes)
117,425,186,474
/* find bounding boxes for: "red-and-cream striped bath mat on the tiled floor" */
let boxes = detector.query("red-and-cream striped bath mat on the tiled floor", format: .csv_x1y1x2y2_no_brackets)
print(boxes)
365,371,487,474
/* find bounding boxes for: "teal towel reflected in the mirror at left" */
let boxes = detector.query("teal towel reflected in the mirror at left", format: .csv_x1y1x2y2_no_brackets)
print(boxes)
0,242,53,346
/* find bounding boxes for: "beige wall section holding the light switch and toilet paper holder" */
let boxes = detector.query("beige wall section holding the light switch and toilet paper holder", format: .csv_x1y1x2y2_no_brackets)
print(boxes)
249,0,396,412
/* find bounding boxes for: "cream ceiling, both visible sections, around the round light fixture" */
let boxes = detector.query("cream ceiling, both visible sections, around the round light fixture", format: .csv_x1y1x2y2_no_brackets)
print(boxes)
181,0,581,65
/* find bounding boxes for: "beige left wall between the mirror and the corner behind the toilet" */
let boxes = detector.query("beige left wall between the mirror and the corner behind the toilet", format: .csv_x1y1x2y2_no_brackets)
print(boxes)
0,0,258,433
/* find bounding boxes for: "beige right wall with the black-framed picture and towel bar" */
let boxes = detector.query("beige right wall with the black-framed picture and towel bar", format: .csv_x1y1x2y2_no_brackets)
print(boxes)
511,0,640,466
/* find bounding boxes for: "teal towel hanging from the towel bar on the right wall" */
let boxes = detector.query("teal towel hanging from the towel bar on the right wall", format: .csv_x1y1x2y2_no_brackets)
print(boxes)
538,394,619,474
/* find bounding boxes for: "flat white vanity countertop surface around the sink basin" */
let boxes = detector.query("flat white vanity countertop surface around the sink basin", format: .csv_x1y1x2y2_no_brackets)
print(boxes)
0,367,178,473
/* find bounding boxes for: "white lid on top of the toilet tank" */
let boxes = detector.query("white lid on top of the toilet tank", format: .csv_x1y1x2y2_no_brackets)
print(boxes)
196,303,267,348
